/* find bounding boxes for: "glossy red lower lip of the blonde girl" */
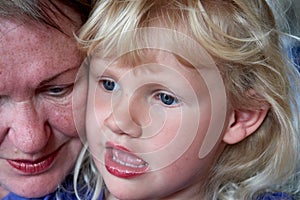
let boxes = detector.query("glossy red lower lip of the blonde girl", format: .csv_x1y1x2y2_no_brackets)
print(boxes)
105,146,148,179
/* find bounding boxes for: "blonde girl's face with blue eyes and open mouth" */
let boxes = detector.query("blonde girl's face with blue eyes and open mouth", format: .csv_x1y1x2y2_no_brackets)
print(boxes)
86,50,225,199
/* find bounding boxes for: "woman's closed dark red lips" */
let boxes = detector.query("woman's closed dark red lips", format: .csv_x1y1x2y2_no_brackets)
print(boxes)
7,149,60,175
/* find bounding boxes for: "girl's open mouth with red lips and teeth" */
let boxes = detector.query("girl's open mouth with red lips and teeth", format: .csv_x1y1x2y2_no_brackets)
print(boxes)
105,144,148,178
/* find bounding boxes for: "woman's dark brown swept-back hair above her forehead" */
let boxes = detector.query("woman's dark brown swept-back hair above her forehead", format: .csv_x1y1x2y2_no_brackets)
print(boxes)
0,0,83,37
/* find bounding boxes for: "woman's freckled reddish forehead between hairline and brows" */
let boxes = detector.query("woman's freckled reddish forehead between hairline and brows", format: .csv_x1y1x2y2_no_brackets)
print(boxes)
0,19,83,84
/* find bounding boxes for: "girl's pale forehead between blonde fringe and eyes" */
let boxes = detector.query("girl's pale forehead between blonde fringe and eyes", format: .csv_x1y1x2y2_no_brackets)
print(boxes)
90,49,218,93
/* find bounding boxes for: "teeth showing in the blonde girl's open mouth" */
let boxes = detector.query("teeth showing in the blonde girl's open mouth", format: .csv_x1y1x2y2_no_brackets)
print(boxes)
112,149,147,168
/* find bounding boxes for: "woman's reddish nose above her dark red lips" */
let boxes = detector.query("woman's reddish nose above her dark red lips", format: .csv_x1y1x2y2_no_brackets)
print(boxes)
8,101,51,153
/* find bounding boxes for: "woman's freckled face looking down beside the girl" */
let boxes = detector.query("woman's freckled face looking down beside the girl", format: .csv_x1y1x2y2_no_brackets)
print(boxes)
0,14,82,197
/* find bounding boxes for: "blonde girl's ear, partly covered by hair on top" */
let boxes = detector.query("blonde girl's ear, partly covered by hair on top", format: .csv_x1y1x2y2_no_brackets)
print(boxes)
223,108,269,144
